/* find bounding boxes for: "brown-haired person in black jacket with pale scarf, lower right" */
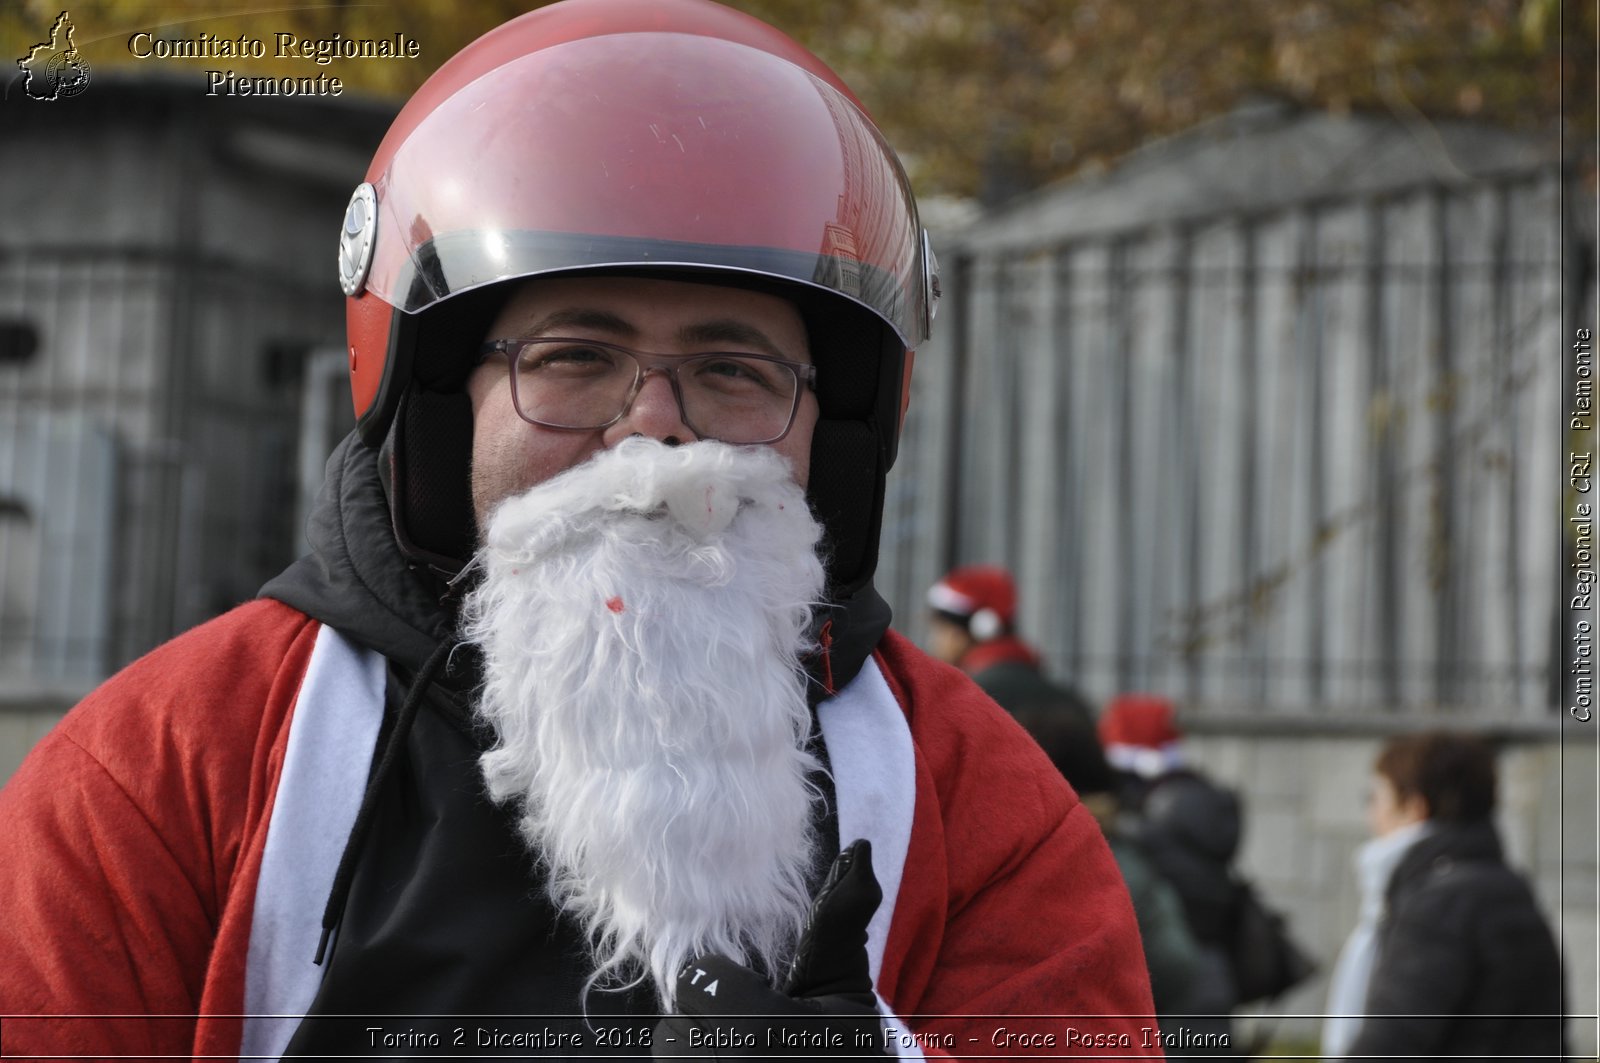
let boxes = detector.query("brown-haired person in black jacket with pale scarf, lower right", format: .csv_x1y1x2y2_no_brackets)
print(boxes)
1323,730,1565,1060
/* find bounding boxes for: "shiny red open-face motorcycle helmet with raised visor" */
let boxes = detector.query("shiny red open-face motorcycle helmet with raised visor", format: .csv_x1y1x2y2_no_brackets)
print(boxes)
339,0,938,591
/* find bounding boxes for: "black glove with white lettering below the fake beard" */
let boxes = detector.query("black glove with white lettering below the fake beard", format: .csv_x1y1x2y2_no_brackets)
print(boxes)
651,839,885,1060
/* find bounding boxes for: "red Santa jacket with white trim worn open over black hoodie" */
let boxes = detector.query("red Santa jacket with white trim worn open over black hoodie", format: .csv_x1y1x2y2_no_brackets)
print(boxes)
0,600,1160,1058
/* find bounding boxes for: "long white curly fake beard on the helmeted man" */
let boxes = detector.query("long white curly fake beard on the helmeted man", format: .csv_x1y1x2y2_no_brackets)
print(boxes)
466,439,822,1010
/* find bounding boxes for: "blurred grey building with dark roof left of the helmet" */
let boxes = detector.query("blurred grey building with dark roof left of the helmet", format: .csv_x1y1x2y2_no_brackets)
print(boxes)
0,75,394,775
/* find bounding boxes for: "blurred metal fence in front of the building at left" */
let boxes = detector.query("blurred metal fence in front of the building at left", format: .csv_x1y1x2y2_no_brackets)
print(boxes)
0,248,338,688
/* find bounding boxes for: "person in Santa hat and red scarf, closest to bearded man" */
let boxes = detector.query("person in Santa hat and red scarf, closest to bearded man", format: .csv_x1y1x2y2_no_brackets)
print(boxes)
928,565,1094,728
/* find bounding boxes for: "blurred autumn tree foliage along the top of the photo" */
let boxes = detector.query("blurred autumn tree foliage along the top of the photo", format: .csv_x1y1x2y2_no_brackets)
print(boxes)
0,0,1600,202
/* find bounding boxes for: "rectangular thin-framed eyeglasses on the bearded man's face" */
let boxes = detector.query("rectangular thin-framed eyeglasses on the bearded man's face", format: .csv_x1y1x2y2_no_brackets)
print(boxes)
480,338,816,443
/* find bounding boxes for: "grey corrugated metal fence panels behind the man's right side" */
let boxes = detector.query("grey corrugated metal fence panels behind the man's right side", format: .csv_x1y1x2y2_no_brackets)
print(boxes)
880,165,1571,719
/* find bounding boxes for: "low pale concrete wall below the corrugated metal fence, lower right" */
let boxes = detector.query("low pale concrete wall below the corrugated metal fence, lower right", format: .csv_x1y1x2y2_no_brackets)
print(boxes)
1190,727,1600,1057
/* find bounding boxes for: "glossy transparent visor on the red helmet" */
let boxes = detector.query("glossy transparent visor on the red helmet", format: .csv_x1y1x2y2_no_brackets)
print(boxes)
366,34,930,347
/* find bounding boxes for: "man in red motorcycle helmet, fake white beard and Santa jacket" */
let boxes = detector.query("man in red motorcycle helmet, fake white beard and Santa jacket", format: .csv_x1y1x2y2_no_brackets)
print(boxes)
0,0,1152,1058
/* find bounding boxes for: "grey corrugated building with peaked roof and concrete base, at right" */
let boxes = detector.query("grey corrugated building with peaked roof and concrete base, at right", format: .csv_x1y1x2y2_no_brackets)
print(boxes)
878,101,1597,1053
